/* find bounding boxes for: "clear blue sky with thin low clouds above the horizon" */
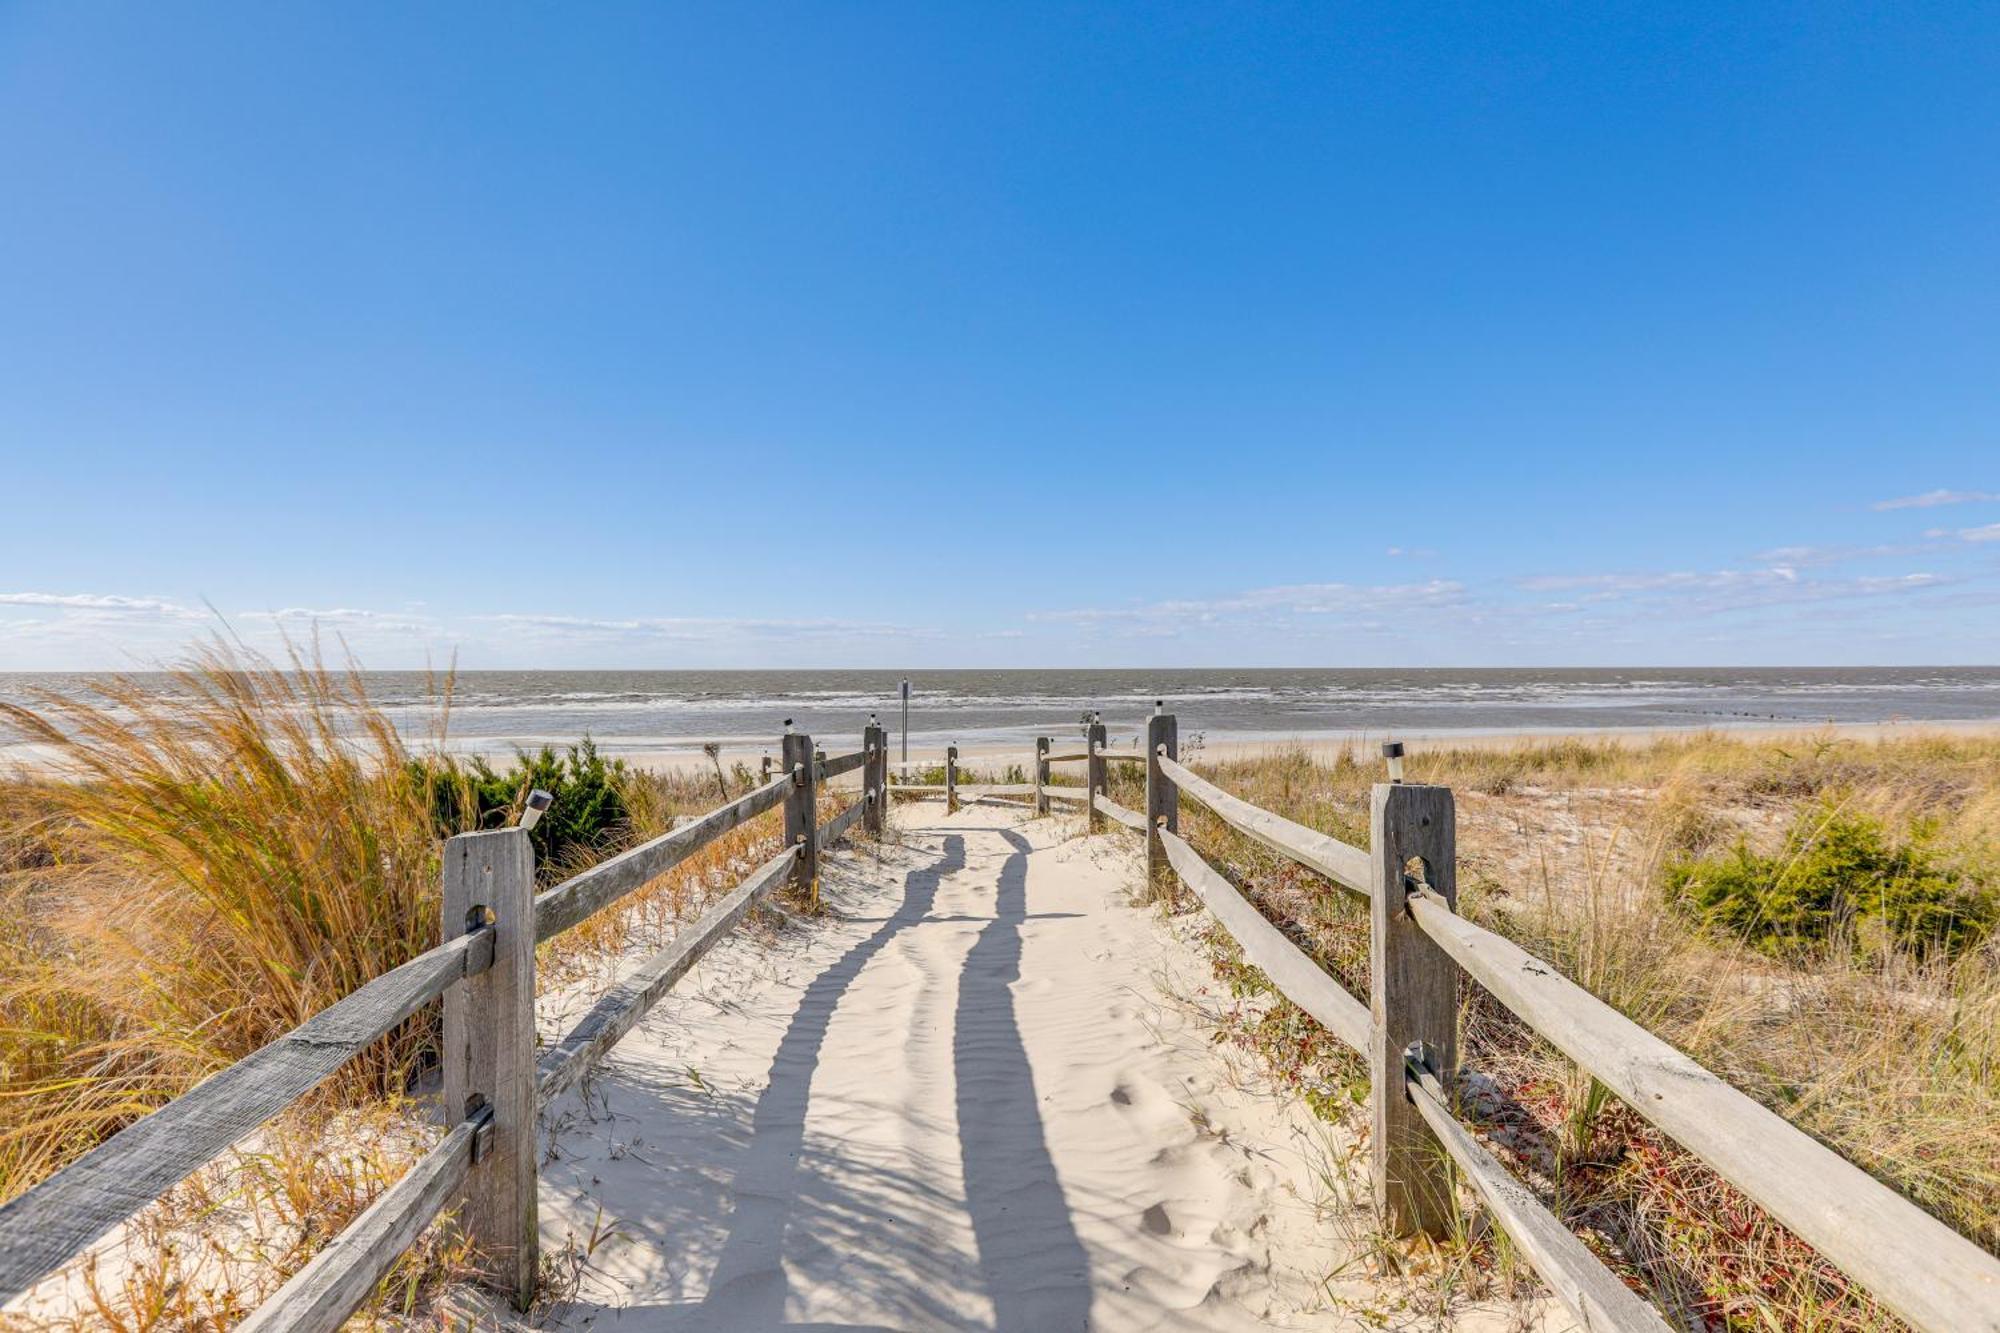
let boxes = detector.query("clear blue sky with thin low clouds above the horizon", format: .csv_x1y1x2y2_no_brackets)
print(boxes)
0,2,2000,669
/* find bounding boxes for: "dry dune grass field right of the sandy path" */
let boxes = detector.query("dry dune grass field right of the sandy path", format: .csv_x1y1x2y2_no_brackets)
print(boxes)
1112,737,2000,1329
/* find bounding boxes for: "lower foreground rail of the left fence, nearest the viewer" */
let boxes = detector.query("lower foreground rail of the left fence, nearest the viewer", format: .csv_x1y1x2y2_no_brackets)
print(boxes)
236,1121,478,1333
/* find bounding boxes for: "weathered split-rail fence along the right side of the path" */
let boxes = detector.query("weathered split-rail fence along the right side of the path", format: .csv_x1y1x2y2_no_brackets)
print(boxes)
1016,715,2000,1333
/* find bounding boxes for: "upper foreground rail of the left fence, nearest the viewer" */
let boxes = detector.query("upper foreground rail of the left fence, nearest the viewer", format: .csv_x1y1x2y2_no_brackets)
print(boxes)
0,927,494,1301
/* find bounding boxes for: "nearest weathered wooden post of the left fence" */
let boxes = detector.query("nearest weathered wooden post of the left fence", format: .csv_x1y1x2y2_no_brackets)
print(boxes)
444,829,540,1309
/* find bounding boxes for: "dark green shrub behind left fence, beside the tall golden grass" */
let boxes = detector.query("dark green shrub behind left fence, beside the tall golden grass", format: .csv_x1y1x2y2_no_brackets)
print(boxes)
428,737,632,873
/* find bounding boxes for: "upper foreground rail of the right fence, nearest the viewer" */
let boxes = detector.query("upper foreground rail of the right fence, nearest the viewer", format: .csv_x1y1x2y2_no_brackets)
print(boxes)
1410,880,2000,1333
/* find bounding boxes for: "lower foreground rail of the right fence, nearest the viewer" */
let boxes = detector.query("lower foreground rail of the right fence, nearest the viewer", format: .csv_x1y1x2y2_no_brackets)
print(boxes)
1410,1069,1670,1333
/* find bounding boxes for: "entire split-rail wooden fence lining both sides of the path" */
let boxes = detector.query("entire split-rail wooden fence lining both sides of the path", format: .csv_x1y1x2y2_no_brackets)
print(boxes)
0,713,2000,1333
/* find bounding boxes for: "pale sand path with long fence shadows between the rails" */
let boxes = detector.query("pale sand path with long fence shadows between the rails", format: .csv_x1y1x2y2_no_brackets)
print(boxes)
542,805,1560,1331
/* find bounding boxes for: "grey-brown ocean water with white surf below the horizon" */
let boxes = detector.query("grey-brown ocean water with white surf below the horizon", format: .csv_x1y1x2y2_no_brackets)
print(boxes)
0,667,2000,753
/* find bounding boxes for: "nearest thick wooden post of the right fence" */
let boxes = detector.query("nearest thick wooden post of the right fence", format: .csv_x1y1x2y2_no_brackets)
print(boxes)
1368,783,1458,1237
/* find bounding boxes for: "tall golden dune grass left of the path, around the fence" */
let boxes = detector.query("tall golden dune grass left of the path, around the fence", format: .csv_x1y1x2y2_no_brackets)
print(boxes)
0,642,832,1331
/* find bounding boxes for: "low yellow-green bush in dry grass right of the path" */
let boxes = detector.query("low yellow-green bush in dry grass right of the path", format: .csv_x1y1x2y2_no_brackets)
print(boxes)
1666,801,2000,957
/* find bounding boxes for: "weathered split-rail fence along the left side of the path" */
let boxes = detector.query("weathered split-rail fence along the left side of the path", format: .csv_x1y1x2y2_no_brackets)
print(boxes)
0,723,888,1333
